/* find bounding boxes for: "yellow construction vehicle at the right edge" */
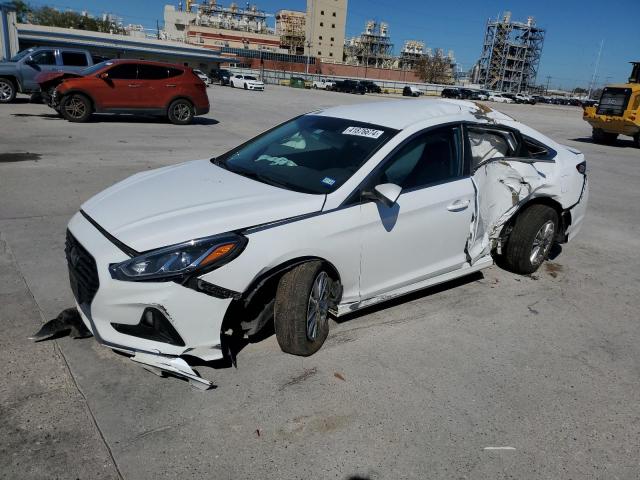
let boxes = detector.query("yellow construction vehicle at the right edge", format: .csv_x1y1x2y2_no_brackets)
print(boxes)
582,62,640,148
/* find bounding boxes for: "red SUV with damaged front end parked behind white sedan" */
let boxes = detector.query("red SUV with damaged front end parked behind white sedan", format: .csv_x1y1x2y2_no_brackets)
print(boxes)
45,60,209,125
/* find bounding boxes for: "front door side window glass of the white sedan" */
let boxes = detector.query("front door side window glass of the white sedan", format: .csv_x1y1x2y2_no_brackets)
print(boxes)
377,127,463,190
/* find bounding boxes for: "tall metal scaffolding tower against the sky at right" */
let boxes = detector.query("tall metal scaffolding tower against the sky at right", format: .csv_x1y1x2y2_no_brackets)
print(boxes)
478,12,545,93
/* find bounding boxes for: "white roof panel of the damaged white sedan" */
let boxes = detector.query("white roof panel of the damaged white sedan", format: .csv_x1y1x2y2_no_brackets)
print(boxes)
314,99,488,130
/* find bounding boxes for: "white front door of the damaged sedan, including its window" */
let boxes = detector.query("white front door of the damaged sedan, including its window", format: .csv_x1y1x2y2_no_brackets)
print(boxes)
360,125,475,300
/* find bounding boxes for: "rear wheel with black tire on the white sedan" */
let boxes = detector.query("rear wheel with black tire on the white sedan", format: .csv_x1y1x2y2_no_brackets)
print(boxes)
502,205,558,275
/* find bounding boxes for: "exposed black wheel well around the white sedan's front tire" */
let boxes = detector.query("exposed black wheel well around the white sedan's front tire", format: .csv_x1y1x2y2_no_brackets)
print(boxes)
222,256,342,336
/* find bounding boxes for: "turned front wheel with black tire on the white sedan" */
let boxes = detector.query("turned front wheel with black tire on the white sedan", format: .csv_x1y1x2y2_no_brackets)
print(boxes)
273,262,332,357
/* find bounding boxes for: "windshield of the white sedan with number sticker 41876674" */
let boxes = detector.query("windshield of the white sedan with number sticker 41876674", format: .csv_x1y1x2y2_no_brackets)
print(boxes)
213,115,397,194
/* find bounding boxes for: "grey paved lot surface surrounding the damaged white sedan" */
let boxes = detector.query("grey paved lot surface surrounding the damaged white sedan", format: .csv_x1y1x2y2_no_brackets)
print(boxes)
0,86,640,479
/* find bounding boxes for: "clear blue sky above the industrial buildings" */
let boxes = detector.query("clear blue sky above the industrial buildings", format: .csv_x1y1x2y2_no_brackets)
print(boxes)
27,0,640,88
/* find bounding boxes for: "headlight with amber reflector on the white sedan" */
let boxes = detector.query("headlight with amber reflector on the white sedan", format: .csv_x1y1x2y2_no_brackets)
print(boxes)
109,233,248,282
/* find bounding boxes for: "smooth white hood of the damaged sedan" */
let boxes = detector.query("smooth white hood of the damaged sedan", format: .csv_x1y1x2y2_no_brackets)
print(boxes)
82,160,325,252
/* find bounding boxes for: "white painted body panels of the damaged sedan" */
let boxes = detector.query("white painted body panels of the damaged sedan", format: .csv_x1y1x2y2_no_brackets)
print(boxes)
69,100,588,386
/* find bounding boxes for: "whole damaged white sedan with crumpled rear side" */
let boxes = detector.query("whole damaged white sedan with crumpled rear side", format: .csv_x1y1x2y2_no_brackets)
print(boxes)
66,100,587,385
